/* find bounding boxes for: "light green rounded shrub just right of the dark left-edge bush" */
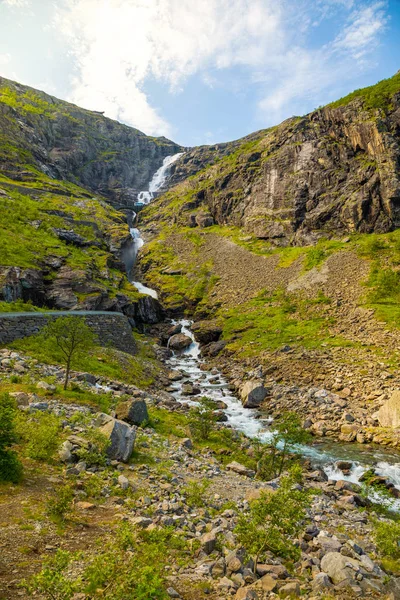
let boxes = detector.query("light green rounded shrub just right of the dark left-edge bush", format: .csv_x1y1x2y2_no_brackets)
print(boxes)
17,411,61,462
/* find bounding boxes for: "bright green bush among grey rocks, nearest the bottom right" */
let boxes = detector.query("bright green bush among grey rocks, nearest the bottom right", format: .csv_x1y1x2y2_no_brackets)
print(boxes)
235,465,312,570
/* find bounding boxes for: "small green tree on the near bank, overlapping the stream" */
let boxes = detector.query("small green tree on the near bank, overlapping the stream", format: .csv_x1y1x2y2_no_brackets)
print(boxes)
255,412,311,480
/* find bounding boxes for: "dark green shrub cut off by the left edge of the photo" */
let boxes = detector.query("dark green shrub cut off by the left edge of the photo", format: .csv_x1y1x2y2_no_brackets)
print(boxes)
0,394,22,483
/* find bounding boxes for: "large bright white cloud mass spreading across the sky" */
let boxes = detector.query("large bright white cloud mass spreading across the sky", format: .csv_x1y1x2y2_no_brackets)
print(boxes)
51,0,387,135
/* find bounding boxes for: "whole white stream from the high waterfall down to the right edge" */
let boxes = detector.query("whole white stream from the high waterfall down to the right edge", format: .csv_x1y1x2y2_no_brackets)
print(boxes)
130,153,400,502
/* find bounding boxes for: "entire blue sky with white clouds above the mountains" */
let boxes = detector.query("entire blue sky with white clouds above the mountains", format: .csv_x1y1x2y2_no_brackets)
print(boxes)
0,0,400,146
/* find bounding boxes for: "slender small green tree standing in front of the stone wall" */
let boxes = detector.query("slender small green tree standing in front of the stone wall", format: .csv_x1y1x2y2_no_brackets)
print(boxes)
43,316,96,390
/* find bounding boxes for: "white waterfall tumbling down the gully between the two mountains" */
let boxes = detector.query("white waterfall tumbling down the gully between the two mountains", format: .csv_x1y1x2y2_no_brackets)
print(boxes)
129,152,183,300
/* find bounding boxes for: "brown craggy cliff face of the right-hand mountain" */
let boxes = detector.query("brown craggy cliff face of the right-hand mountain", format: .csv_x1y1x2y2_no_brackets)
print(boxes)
156,74,400,246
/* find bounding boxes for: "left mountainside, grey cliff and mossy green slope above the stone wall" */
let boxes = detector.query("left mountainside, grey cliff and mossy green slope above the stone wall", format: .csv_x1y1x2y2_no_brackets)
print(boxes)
0,79,179,322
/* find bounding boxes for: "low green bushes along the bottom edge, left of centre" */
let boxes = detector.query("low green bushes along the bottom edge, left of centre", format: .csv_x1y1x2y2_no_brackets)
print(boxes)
25,523,187,600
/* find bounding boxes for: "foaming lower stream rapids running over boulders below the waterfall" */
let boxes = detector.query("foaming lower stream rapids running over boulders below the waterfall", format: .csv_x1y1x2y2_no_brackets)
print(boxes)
168,320,400,502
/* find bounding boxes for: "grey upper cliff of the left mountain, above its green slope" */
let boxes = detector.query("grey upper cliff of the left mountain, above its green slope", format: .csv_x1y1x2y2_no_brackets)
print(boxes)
0,77,181,207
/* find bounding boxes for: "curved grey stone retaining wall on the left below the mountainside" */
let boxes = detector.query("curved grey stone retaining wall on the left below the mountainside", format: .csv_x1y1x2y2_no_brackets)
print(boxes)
0,311,137,354
